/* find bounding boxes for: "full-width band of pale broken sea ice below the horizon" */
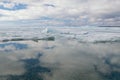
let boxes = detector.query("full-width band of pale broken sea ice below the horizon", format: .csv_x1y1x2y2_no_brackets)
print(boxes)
0,26,120,42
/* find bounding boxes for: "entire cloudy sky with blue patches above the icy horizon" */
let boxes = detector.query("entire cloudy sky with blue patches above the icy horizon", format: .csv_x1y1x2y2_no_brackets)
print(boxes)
0,0,120,27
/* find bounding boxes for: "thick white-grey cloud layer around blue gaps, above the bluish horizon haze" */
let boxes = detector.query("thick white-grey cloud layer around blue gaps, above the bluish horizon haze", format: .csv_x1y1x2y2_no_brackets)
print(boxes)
0,0,120,25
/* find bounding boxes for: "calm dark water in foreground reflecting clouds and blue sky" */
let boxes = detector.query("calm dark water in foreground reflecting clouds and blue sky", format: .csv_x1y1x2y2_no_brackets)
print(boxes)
0,40,120,80
